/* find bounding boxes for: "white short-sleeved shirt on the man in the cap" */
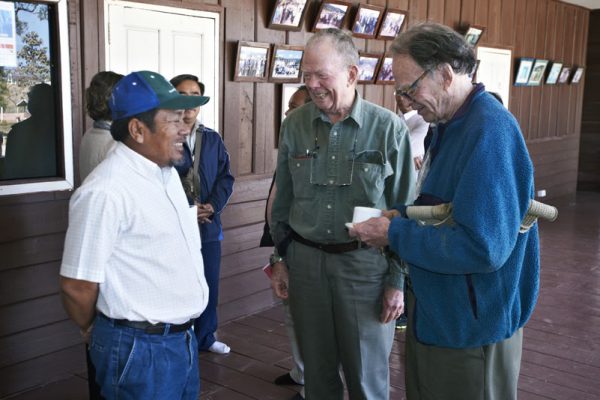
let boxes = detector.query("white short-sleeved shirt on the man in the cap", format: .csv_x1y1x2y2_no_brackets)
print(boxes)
60,143,208,324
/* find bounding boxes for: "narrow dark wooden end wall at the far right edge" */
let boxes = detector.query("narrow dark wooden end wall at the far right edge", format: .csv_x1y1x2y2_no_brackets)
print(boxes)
577,10,600,192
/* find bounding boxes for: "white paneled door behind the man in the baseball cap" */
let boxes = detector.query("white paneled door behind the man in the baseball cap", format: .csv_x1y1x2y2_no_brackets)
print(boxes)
105,0,219,130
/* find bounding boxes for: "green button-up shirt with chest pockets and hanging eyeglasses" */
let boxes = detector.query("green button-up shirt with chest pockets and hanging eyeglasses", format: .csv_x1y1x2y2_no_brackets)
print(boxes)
271,92,415,287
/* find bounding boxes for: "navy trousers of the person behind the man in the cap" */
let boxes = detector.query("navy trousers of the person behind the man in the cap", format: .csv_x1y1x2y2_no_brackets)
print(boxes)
194,240,221,351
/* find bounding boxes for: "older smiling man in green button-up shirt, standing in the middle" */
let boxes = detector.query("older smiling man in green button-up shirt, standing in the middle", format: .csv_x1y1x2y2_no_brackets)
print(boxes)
271,29,415,400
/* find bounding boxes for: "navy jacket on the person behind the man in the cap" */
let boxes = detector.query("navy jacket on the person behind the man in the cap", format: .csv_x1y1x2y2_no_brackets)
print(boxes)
175,126,234,243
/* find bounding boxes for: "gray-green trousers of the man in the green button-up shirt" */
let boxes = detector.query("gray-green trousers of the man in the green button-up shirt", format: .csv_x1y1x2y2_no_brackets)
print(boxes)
286,241,394,400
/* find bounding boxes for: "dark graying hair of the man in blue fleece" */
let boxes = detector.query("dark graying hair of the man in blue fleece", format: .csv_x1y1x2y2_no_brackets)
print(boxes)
390,22,476,74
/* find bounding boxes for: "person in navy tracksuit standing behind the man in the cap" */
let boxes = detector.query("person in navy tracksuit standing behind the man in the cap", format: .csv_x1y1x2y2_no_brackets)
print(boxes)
171,74,234,354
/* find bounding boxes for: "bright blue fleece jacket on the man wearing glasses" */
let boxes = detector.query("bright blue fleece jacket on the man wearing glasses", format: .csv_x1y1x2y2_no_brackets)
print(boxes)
388,86,540,348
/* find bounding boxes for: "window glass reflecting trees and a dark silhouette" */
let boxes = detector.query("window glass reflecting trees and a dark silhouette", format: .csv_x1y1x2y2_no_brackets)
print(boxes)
0,1,62,184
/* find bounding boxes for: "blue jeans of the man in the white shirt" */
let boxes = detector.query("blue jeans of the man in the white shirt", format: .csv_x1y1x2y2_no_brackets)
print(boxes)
90,315,200,400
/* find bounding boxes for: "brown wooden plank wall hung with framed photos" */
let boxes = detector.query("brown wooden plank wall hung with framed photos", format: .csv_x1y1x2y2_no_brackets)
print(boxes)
0,0,598,398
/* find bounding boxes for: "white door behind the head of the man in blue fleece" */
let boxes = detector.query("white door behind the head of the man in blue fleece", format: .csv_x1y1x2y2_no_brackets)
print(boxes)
475,46,512,108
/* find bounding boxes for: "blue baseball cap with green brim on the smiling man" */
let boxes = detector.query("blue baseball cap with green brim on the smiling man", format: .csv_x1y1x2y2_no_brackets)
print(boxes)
108,71,207,121
